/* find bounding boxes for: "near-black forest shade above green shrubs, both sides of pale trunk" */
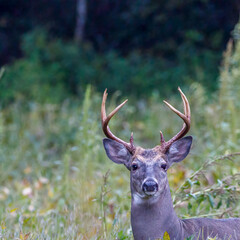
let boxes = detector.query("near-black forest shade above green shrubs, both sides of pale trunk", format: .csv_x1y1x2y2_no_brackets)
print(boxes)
0,0,239,63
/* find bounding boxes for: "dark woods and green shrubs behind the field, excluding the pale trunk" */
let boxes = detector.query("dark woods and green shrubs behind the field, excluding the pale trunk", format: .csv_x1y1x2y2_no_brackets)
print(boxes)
0,0,240,98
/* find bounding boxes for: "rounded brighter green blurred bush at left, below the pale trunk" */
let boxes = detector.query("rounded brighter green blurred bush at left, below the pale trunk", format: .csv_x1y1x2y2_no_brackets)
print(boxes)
1,30,88,102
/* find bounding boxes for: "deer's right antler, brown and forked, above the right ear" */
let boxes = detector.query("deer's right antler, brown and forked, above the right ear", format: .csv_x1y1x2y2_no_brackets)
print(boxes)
160,87,191,151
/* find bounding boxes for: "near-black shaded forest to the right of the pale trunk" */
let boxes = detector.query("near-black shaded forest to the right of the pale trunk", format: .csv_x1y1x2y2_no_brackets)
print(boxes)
87,0,240,56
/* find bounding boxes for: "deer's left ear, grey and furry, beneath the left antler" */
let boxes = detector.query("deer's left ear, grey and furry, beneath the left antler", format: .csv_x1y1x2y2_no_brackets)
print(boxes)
103,138,131,169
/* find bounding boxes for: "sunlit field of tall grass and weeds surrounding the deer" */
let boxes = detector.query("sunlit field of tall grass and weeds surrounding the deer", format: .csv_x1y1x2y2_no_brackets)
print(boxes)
0,40,240,240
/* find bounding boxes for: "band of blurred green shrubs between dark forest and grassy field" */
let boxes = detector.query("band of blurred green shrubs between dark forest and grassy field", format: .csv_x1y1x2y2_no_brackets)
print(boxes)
0,29,217,104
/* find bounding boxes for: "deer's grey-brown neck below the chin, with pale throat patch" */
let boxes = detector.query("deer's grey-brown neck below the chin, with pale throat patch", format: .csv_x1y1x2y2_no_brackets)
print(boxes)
131,183,183,240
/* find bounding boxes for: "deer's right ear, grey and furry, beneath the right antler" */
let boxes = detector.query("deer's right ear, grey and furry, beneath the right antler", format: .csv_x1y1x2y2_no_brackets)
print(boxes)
167,136,192,165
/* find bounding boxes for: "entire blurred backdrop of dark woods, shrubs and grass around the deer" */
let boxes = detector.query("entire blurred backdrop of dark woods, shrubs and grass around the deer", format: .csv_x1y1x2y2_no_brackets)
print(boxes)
0,0,240,240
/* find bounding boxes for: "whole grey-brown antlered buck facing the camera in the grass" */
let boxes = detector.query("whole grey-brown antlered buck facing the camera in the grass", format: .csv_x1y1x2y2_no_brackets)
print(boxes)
101,88,240,240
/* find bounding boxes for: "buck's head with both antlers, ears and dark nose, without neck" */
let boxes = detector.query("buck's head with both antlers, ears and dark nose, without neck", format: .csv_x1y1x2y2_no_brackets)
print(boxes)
101,88,192,200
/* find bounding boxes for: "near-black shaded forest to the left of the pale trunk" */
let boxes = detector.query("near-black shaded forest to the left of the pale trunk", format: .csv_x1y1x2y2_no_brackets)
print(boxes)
0,0,76,65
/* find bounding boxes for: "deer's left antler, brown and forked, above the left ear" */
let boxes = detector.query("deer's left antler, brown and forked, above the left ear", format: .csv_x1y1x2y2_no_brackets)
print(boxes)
101,89,135,153
